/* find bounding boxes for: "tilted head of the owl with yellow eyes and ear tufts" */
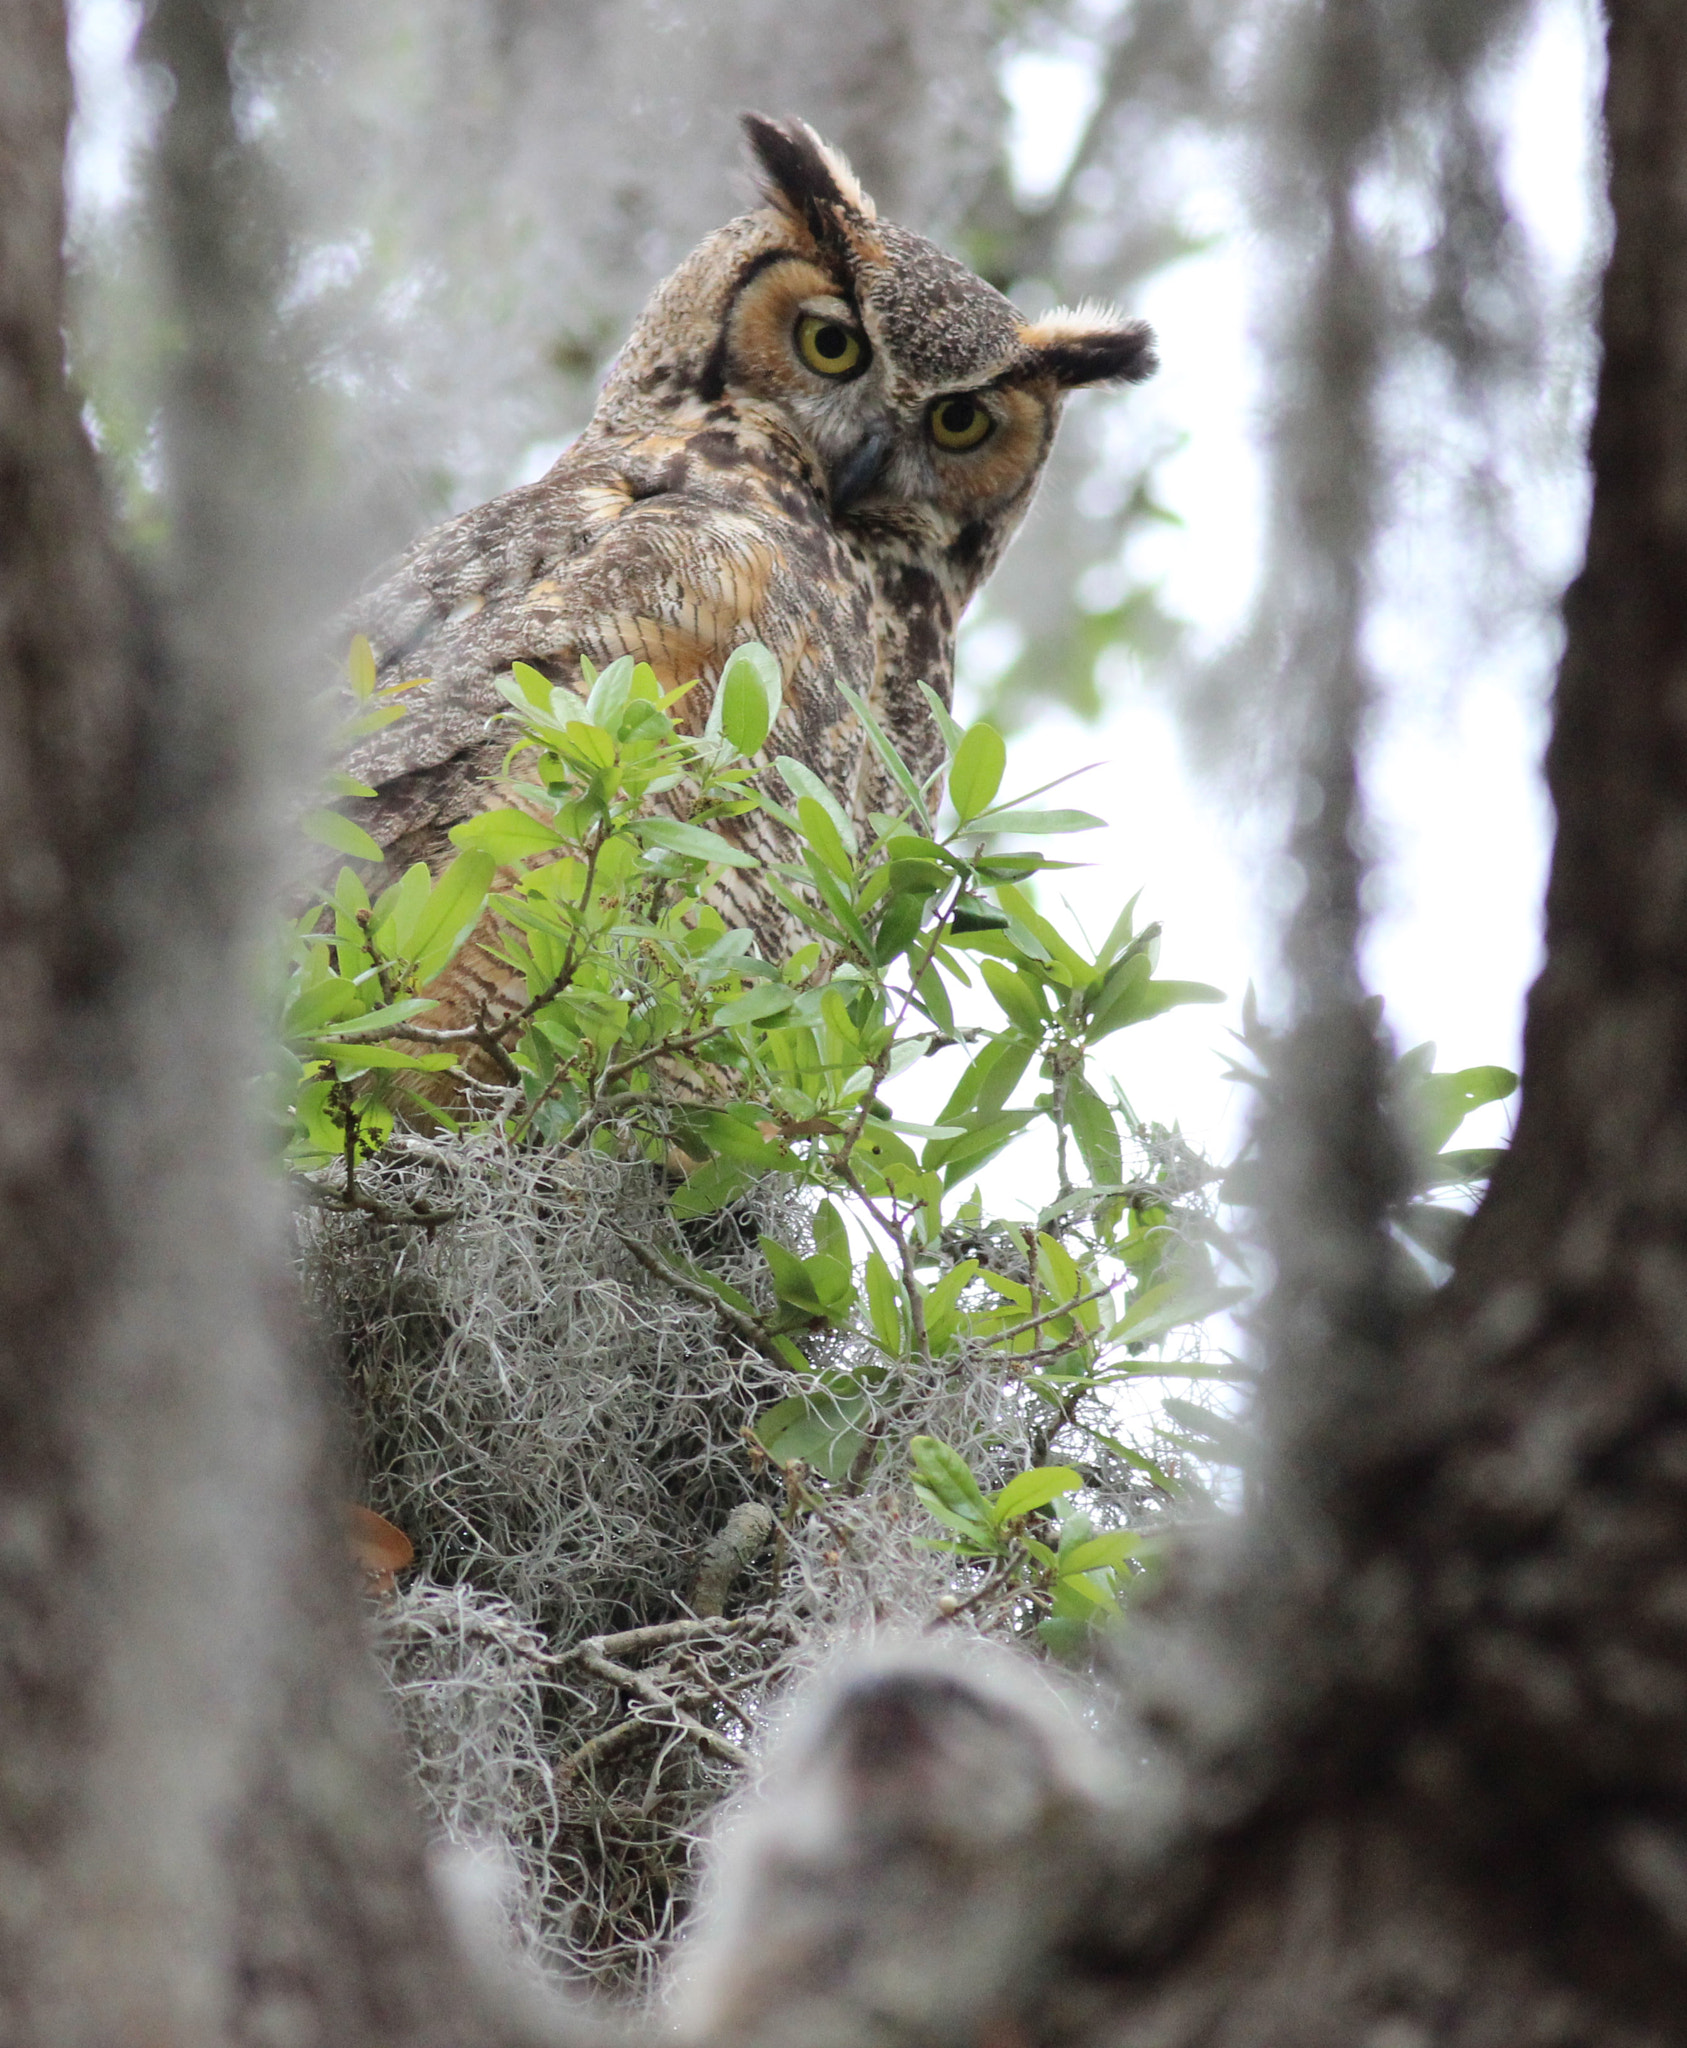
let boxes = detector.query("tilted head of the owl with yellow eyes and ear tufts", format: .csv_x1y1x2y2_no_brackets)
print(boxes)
600,115,1155,598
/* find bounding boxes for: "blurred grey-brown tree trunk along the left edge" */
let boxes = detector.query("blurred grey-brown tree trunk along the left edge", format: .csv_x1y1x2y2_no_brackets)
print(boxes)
0,0,540,2048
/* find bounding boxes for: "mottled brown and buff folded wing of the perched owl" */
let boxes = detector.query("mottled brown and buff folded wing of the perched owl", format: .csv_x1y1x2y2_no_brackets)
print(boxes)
333,434,872,862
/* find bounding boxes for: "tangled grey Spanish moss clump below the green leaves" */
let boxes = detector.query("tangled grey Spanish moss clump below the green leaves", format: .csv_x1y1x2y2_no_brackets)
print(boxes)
299,1135,1142,1991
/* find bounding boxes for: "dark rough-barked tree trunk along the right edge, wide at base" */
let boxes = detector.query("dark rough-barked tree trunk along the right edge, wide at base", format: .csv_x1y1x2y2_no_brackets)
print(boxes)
1097,0,1687,2048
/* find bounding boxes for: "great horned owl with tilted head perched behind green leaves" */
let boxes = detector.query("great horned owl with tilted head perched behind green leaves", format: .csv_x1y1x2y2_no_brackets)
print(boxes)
350,115,1155,1024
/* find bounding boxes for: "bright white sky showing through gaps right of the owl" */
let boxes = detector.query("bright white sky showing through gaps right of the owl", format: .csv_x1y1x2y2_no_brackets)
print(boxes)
937,0,1597,1187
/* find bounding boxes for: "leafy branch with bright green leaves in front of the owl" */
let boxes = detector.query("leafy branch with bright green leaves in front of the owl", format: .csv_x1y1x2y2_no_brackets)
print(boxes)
270,645,1511,1662
